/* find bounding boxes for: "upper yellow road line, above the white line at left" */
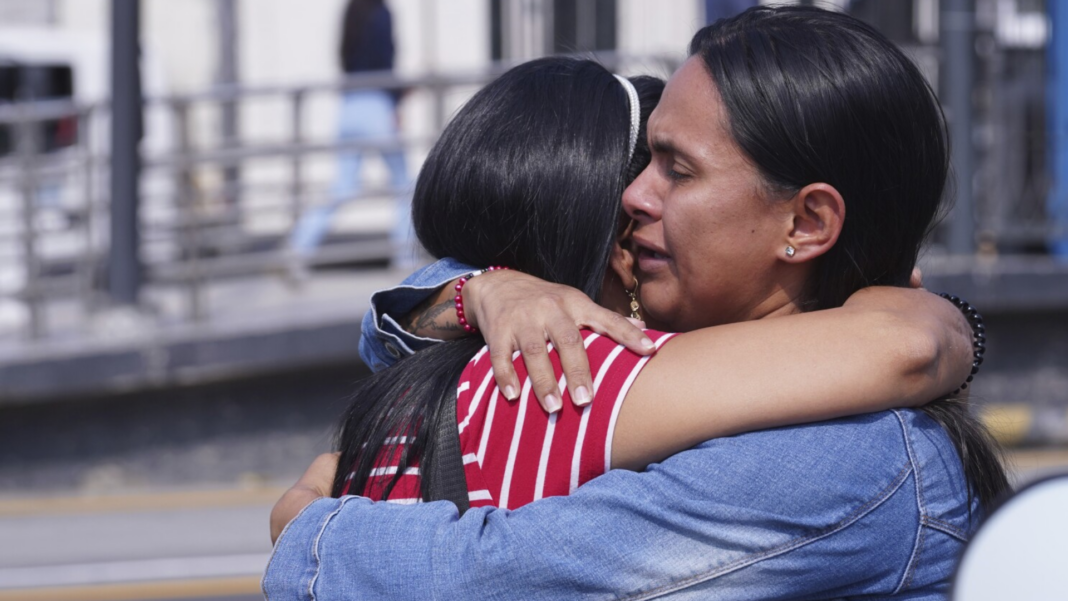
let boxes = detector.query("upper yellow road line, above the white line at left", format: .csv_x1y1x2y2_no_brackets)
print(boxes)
0,487,285,518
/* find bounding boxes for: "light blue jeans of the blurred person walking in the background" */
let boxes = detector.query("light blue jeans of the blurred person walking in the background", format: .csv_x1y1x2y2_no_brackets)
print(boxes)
289,90,414,265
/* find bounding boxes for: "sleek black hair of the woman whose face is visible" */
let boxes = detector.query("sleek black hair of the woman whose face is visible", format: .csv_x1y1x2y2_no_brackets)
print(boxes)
690,6,1009,507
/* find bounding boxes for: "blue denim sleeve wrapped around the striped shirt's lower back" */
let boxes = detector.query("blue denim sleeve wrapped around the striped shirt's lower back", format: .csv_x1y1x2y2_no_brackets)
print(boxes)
264,412,962,600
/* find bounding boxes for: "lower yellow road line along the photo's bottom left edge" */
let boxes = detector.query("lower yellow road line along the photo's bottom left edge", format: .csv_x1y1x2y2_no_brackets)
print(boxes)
0,576,261,601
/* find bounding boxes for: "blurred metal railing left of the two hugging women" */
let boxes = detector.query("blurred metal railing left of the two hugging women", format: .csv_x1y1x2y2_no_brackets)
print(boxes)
0,53,676,339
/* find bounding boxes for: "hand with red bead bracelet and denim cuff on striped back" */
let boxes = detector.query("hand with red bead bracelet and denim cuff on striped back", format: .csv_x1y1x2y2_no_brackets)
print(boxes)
360,258,654,410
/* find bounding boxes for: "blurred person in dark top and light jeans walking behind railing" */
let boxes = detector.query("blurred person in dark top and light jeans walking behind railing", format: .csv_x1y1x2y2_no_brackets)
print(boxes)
288,0,413,279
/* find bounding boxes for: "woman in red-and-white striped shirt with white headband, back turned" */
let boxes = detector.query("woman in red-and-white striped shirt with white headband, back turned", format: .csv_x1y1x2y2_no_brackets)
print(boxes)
333,58,971,508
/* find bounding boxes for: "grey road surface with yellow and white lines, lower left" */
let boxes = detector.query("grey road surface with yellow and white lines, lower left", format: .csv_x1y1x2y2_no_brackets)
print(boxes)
0,488,281,601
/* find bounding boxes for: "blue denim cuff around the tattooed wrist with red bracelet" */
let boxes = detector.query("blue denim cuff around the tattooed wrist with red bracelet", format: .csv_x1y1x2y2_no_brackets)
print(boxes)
360,258,477,371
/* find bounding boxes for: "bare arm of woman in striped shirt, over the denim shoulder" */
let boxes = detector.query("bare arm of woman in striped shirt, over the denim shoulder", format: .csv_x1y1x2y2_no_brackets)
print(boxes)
595,287,972,470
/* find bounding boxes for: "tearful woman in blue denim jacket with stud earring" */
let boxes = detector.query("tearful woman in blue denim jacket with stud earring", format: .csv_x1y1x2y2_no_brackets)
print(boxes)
265,10,1004,598
